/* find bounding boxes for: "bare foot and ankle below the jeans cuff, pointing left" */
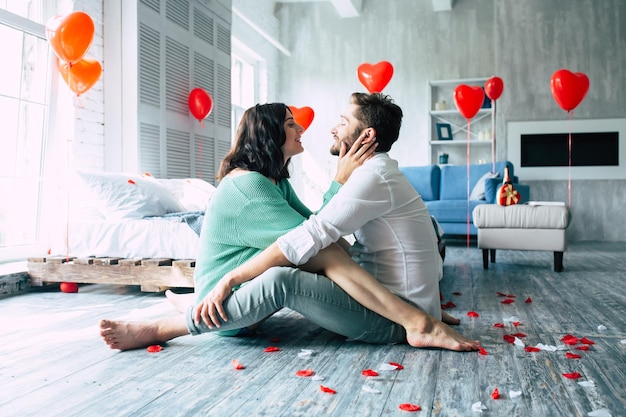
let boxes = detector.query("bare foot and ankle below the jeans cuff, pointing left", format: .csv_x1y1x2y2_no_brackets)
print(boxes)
100,315,189,350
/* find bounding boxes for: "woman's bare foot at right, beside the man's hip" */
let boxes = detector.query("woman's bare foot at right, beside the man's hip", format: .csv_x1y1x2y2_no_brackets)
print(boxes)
406,317,480,351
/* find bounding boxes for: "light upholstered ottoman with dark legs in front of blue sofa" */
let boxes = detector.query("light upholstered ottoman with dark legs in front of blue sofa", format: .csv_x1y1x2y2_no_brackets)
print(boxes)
472,204,571,272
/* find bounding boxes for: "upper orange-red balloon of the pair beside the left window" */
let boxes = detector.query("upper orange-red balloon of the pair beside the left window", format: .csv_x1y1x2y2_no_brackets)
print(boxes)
46,11,94,64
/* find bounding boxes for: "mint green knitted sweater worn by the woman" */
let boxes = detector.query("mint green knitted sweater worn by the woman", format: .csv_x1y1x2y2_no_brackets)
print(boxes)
194,172,340,301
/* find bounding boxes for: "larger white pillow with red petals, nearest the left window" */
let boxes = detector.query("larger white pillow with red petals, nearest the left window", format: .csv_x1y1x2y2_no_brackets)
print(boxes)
78,172,185,220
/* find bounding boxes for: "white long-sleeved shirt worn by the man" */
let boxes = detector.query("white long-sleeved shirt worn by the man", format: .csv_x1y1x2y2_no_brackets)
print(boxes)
278,153,443,319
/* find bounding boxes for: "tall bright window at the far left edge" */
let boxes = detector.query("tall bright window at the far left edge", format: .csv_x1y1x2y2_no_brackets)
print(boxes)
0,4,51,261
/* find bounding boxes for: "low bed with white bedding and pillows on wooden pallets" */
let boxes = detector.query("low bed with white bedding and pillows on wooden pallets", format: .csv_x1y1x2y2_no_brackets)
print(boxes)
27,172,215,291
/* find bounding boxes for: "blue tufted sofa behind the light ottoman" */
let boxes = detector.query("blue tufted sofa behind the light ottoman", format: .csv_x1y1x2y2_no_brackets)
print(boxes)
400,161,530,235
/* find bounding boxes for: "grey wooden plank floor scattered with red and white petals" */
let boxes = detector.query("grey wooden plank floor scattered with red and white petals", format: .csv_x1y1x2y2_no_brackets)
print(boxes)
0,243,626,417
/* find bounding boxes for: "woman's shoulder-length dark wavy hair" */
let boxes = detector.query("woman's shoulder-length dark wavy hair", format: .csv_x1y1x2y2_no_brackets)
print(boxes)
217,103,289,181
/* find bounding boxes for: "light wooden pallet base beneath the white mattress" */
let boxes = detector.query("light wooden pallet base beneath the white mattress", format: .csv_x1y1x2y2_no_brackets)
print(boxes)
27,257,196,292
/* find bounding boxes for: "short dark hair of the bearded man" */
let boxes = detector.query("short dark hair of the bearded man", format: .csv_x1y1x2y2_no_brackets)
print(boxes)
350,93,402,152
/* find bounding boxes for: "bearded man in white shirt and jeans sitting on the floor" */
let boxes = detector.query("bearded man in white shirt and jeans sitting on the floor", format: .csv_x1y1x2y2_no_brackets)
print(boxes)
101,93,480,351
